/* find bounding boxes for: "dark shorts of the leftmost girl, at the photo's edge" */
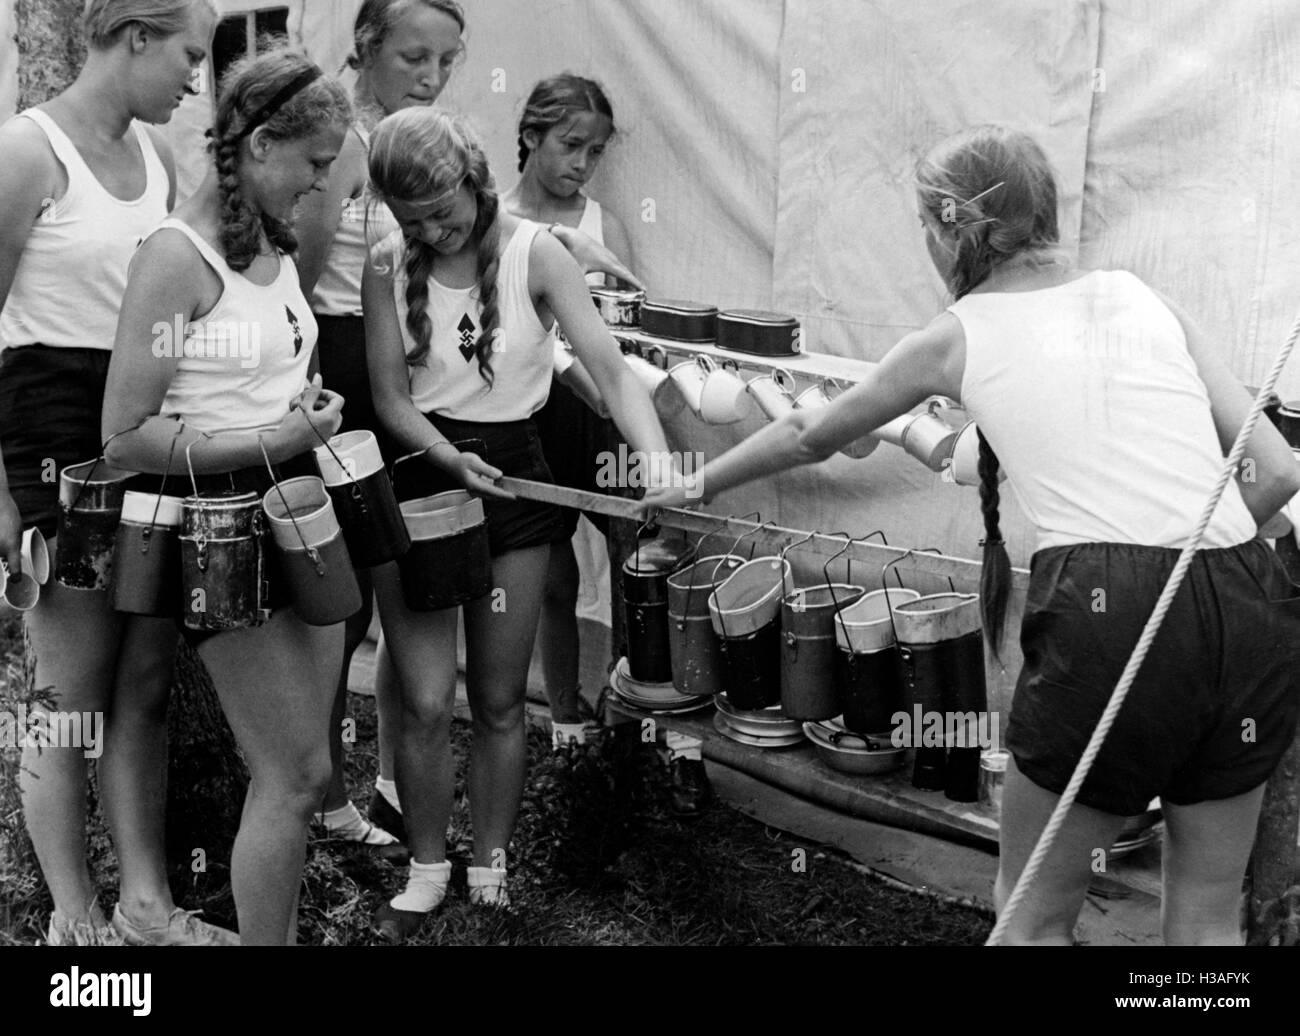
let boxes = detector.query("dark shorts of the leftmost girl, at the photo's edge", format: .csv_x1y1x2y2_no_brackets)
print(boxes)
0,346,112,539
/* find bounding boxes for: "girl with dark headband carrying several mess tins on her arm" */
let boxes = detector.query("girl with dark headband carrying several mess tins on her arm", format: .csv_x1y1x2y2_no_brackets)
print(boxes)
103,51,351,945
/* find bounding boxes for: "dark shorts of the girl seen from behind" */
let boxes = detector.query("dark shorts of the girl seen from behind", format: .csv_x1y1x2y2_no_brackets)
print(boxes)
1006,539,1300,816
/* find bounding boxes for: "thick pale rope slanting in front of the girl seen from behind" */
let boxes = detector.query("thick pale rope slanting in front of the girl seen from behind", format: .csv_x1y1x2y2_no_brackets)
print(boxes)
984,316,1300,946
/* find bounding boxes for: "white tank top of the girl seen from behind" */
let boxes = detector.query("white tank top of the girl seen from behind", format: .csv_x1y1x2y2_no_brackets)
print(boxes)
949,270,1256,550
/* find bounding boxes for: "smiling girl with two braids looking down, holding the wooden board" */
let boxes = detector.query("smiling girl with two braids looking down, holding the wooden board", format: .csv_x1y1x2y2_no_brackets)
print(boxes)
361,108,667,941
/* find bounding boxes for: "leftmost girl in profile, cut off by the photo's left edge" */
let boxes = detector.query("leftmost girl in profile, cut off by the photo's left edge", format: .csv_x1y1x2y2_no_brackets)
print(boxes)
0,0,224,945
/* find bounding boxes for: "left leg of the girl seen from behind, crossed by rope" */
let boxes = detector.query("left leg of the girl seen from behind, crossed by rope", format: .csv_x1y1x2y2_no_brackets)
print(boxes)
993,759,1125,946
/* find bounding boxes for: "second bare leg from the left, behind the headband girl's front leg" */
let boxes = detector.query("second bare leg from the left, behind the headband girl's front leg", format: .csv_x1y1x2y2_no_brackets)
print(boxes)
99,616,179,927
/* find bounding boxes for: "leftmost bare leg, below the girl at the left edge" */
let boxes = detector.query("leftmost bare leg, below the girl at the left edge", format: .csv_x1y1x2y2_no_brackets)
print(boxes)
18,569,121,924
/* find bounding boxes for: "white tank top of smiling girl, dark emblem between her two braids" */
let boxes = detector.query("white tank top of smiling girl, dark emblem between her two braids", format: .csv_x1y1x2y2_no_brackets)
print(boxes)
377,220,554,422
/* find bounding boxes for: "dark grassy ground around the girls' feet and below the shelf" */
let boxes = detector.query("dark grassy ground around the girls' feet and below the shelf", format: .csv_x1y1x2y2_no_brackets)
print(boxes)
0,613,991,945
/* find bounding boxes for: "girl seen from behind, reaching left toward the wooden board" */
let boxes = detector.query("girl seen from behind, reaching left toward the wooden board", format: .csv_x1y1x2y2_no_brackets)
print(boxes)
646,126,1300,944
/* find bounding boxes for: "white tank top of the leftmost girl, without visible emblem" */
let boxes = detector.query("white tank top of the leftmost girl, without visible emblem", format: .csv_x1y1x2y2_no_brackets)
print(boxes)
0,108,172,350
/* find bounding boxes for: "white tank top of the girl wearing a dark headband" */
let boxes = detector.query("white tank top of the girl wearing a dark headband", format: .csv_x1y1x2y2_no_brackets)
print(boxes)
153,218,316,433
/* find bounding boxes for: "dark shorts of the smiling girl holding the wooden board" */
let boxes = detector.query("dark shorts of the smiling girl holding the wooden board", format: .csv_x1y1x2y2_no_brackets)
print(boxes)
393,413,567,558
